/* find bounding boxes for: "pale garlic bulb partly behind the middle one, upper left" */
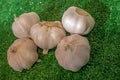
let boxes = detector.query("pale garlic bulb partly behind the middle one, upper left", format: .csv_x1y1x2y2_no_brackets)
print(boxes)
12,12,40,38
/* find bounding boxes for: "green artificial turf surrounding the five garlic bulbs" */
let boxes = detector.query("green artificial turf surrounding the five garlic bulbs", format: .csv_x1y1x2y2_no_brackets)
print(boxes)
0,0,120,80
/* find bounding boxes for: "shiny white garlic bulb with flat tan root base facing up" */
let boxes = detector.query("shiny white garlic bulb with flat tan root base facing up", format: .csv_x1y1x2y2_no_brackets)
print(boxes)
62,6,95,35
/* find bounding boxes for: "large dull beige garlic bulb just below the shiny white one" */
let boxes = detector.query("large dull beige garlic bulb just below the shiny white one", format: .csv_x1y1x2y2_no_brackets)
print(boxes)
55,34,90,72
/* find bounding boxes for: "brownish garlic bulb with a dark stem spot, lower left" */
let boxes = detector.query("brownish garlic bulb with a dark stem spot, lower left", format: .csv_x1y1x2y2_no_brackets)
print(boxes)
7,38,38,72
